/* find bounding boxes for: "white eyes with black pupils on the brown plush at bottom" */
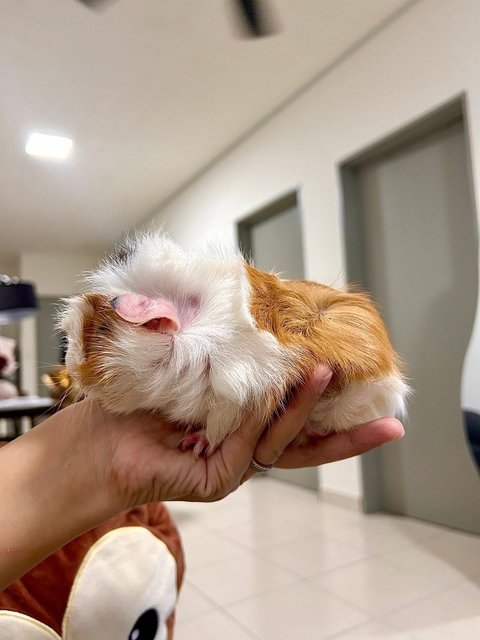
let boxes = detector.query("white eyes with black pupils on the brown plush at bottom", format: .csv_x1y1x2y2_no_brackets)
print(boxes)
0,526,177,640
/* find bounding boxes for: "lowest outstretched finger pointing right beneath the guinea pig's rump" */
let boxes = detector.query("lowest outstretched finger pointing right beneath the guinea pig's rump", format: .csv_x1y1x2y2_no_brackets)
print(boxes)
275,418,405,469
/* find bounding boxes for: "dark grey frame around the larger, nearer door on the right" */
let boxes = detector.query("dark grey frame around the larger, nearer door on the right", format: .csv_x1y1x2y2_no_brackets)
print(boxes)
338,93,477,513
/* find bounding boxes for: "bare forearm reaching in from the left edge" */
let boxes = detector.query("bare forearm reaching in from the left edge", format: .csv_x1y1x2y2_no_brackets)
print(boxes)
0,411,113,590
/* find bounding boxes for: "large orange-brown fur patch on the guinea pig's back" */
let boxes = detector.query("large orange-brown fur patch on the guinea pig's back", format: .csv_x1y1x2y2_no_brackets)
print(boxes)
246,265,398,396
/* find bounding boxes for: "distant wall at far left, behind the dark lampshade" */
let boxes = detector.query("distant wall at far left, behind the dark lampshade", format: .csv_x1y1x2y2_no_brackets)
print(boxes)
18,252,98,394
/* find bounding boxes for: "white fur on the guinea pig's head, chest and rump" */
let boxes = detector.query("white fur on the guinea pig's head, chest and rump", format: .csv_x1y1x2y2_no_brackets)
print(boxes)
62,232,407,445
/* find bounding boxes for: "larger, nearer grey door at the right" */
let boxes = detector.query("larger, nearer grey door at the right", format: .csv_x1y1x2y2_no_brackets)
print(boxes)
350,122,480,532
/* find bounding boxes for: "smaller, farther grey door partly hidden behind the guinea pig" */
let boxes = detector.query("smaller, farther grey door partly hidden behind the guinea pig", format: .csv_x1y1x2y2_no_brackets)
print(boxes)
244,203,318,490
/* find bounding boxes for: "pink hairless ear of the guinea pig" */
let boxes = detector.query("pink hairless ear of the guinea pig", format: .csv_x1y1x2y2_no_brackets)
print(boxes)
110,293,180,335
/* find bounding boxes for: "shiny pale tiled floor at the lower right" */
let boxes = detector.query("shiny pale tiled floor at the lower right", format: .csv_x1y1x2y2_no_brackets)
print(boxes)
170,478,480,640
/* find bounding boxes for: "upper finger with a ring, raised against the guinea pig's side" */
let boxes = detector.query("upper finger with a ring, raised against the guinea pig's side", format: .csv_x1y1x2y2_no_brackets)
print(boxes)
245,366,332,479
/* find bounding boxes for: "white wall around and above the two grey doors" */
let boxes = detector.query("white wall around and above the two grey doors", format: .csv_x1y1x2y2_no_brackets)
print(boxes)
144,0,480,497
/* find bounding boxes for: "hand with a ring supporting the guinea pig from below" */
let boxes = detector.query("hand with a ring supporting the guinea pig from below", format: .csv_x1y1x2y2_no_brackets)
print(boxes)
72,367,403,510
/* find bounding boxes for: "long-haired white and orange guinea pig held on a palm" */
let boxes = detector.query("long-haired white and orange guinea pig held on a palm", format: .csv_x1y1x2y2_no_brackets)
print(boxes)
61,232,408,455
